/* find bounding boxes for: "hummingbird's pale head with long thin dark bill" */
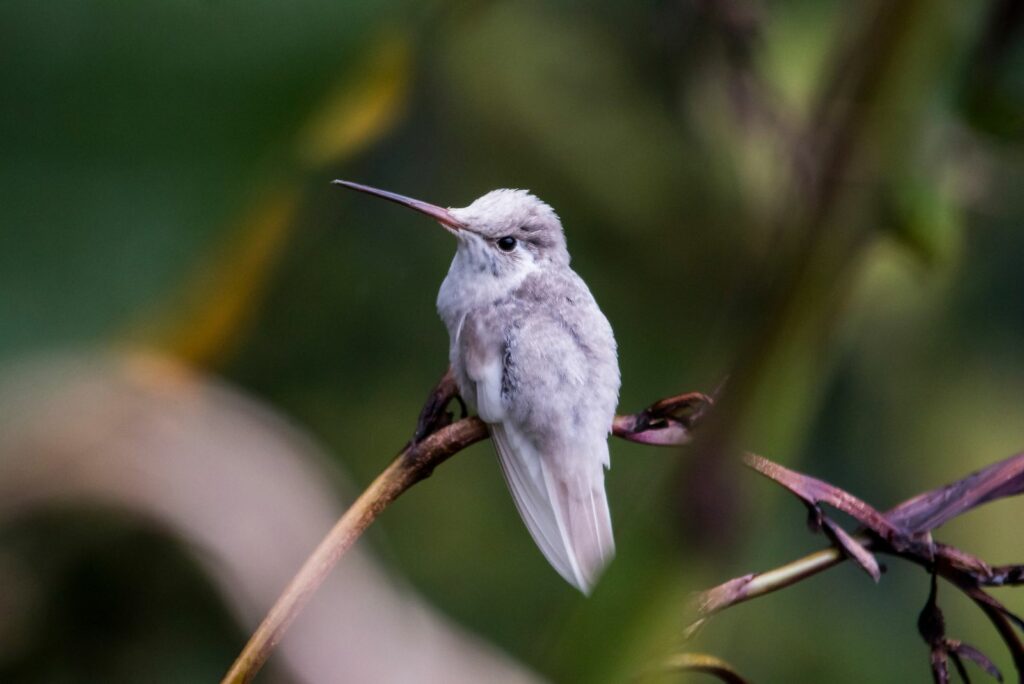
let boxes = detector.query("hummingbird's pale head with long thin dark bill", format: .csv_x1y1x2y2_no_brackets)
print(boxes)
334,180,569,277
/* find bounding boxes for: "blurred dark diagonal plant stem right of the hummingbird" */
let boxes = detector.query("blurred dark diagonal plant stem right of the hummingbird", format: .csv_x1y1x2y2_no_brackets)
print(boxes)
681,0,987,549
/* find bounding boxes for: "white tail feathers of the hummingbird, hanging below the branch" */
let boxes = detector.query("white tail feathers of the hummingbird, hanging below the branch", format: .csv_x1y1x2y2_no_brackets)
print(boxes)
489,423,614,594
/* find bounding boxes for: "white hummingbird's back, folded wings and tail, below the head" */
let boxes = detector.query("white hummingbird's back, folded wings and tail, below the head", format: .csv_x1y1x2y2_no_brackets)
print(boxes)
457,275,618,593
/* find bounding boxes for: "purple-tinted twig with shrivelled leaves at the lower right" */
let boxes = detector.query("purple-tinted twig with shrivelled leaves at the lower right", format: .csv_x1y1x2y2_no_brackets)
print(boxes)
687,454,1024,681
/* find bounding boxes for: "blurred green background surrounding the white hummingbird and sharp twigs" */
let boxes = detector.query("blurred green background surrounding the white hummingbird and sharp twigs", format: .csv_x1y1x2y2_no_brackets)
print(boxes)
0,0,1024,682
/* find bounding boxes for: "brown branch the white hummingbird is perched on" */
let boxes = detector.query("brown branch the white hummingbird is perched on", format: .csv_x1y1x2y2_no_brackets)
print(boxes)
222,371,711,684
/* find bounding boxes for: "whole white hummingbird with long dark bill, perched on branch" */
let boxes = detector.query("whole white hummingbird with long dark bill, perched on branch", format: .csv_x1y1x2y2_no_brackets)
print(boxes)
335,180,620,594
